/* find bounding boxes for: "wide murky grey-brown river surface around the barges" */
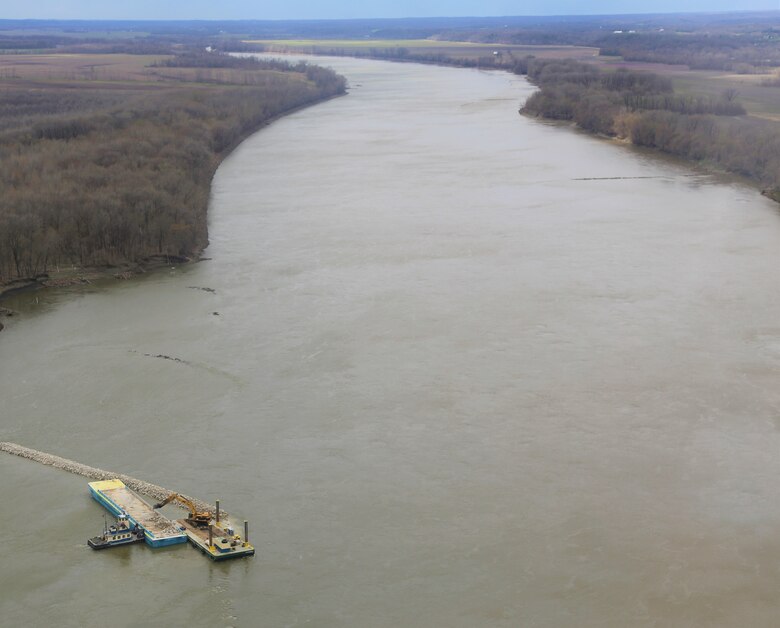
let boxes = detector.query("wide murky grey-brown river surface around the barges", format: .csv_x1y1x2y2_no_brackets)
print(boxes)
0,59,780,628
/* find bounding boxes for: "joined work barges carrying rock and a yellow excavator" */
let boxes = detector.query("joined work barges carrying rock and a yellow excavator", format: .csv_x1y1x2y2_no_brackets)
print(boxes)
89,479,255,560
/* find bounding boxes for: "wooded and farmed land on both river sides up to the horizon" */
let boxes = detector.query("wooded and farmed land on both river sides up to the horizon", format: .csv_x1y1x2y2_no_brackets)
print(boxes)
0,11,780,292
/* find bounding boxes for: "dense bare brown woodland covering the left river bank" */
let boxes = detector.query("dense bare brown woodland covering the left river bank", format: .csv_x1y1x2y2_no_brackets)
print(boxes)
0,57,345,283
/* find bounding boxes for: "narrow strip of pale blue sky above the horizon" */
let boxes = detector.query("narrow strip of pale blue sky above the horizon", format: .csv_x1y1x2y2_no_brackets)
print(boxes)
0,0,780,20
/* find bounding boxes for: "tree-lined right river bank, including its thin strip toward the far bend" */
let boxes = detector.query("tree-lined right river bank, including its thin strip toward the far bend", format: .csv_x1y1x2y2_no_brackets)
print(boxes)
251,48,780,209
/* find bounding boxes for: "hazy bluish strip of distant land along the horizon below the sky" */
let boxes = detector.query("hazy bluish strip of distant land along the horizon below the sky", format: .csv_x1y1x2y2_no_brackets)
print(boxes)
0,10,780,73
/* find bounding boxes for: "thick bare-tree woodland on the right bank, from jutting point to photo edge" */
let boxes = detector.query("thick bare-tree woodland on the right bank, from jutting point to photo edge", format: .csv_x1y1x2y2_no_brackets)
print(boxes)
522,60,780,201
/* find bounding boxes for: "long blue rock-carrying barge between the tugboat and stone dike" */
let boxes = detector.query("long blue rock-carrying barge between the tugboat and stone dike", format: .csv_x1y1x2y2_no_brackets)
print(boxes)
89,479,187,547
